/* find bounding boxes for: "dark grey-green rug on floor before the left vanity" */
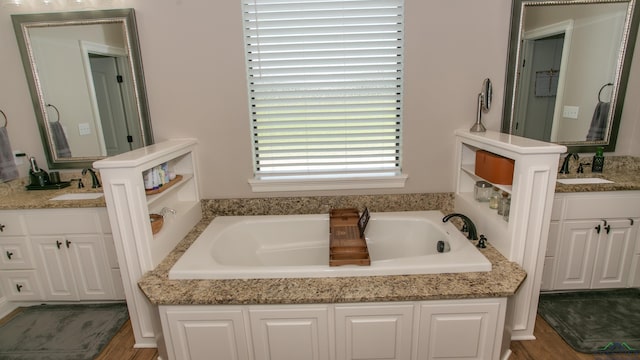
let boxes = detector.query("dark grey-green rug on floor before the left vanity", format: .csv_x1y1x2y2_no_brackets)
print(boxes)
0,303,129,360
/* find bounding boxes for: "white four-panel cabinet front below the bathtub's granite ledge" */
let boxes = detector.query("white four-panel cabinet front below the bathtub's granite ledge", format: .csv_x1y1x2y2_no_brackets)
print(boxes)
159,298,507,360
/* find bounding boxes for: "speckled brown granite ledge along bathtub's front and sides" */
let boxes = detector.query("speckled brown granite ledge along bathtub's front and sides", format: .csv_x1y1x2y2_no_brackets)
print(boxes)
138,219,526,305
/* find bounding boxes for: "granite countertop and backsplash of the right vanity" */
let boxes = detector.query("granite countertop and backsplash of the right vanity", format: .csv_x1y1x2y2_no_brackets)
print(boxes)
556,156,640,193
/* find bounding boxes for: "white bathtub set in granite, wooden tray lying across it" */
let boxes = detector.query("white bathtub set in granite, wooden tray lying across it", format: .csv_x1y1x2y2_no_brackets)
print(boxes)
169,211,491,279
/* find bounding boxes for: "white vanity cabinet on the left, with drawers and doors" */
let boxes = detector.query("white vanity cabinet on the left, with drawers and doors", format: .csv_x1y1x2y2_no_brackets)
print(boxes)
0,208,123,301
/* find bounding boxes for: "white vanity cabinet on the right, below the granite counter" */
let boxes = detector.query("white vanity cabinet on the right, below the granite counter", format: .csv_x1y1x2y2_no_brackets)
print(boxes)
542,191,640,290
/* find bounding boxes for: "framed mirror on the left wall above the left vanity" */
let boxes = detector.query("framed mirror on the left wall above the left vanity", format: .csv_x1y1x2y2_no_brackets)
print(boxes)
12,9,153,169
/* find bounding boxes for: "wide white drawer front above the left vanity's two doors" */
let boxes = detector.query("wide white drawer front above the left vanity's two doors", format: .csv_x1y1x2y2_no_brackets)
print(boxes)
25,209,101,235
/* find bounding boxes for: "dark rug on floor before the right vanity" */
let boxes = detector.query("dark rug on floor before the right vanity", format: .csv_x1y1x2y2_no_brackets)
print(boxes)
538,289,640,354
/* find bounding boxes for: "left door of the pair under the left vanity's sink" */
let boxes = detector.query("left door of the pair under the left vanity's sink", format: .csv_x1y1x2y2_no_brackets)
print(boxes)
31,236,79,300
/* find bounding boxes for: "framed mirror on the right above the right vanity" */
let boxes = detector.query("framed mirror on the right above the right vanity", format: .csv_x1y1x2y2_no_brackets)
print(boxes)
502,0,638,152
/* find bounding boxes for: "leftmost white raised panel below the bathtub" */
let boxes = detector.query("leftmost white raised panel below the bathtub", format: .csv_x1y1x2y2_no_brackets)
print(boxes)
161,307,249,360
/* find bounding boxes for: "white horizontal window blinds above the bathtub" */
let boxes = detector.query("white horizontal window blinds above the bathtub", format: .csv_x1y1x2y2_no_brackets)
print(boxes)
243,0,403,179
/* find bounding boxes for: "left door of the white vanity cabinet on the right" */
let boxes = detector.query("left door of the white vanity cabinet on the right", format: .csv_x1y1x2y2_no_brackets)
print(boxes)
555,220,603,289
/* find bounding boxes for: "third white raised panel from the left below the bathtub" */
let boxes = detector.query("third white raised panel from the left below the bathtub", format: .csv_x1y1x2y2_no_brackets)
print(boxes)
335,305,414,360
